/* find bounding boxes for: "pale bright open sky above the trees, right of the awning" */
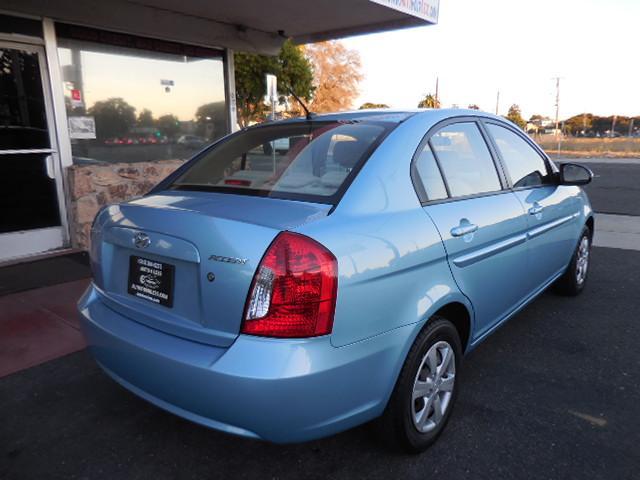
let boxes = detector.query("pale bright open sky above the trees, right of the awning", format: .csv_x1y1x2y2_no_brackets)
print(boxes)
343,0,640,119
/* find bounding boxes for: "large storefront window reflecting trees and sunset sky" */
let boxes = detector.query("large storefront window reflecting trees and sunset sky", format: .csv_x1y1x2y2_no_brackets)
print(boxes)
57,25,228,164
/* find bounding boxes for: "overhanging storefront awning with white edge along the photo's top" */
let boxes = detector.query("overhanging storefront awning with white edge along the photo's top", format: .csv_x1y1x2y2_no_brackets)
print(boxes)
2,0,439,53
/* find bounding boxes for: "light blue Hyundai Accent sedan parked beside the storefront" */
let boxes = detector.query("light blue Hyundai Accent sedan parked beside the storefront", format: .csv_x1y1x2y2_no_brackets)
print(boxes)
79,110,594,452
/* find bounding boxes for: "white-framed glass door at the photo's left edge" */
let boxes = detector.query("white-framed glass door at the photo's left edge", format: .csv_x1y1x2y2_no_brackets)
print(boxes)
0,41,65,262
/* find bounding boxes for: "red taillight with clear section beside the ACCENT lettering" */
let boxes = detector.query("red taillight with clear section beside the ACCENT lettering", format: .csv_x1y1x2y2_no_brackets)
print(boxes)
242,232,338,338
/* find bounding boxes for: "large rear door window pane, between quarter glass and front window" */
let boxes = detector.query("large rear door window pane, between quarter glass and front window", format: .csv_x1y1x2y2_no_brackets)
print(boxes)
430,122,502,197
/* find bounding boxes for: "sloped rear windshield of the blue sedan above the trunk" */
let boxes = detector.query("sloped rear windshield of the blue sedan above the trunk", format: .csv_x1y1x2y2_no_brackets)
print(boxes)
171,122,393,203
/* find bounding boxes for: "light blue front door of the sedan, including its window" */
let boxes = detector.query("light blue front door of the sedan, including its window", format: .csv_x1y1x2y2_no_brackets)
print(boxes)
485,122,581,290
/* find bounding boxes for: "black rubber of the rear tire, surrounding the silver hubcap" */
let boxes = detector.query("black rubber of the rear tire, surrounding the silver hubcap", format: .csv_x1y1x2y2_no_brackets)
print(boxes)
376,316,462,453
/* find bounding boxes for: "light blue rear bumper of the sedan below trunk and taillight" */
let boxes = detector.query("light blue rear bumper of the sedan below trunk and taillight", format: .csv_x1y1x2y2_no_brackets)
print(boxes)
78,286,415,443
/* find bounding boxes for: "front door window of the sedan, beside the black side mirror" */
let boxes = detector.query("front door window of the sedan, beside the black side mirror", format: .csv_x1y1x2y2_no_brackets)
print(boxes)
487,123,551,188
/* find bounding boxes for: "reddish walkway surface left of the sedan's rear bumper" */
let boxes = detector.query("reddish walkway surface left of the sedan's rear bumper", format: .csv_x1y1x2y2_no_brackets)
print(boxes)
0,279,89,378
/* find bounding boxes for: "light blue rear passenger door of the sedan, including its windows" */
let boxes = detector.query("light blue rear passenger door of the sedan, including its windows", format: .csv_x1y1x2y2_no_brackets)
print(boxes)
414,120,528,338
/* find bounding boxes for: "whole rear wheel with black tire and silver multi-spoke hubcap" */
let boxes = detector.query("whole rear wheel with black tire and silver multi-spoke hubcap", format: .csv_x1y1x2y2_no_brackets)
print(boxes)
377,316,462,453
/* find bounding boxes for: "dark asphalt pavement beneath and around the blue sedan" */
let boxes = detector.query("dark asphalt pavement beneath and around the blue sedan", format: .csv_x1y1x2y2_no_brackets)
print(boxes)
0,248,640,480
